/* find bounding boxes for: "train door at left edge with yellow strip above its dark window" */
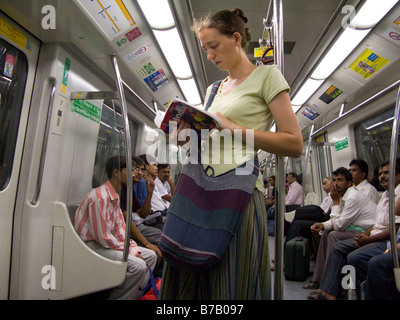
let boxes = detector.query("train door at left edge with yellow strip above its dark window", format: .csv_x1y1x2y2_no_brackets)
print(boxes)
0,14,40,299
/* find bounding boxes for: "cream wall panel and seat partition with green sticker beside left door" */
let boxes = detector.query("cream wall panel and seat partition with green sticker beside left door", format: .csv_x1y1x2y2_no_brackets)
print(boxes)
9,43,130,300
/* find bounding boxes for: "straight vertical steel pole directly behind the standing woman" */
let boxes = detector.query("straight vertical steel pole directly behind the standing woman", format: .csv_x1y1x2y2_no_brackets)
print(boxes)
273,0,286,300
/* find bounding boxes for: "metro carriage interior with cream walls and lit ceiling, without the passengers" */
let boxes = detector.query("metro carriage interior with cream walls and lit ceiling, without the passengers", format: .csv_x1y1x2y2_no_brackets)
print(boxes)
0,0,400,300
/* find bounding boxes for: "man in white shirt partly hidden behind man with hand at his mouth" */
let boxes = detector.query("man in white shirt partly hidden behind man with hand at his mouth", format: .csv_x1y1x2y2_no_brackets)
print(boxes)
349,159,380,203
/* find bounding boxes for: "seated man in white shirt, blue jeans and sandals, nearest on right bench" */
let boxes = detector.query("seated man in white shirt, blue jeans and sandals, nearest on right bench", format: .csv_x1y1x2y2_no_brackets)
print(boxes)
309,160,400,300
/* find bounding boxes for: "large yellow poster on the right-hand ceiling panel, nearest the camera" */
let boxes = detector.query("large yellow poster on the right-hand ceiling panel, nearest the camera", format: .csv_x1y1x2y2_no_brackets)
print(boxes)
349,49,389,79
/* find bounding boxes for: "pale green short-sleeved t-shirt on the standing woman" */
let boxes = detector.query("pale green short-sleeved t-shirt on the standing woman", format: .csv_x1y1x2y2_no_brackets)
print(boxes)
201,65,289,191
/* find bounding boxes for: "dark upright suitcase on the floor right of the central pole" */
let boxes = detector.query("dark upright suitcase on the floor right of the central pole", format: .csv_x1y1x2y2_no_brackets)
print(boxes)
284,237,310,281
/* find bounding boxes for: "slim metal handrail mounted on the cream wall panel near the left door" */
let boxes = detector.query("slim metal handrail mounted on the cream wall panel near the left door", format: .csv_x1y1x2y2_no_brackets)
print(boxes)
31,77,57,205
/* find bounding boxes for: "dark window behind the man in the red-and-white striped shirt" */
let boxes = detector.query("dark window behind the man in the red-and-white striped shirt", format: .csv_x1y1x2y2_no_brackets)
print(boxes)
92,101,139,188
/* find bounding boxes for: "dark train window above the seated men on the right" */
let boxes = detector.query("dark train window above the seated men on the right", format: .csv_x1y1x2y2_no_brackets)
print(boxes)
354,108,400,179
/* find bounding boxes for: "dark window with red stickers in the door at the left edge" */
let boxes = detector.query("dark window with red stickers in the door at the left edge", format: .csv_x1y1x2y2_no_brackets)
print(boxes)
0,39,28,190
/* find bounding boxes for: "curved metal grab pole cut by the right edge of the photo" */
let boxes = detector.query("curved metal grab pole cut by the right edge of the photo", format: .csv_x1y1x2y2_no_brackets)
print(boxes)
389,86,400,291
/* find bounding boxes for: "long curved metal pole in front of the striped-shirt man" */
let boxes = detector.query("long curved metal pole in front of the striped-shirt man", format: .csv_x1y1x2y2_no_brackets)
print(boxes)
110,55,133,262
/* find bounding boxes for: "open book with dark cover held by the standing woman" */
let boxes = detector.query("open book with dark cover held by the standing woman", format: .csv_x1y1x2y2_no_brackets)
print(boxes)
154,98,221,133
